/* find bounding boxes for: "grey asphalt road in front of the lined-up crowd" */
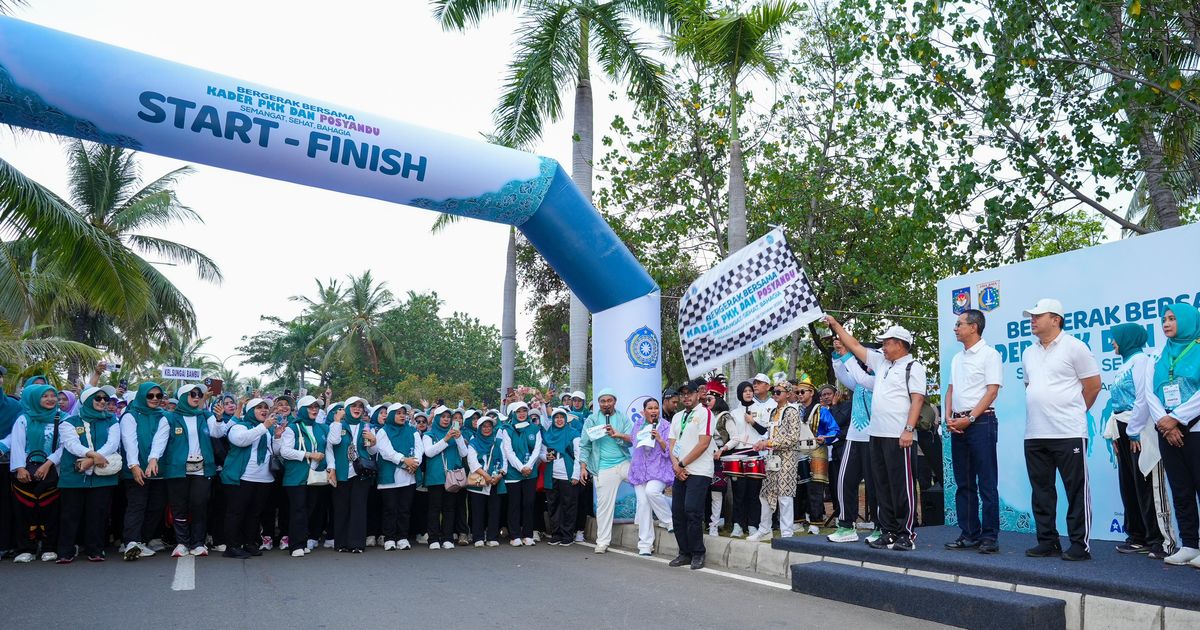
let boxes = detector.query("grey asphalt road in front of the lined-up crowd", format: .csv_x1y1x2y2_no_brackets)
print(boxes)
0,545,955,630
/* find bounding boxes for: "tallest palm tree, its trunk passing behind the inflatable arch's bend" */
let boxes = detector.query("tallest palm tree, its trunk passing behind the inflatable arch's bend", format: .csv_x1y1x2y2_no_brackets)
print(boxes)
432,0,670,389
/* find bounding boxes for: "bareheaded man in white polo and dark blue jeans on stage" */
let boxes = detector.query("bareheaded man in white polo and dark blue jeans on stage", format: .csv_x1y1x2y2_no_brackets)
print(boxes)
946,308,1004,553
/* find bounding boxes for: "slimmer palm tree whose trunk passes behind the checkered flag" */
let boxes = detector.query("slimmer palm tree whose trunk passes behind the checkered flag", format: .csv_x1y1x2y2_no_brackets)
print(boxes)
670,0,803,383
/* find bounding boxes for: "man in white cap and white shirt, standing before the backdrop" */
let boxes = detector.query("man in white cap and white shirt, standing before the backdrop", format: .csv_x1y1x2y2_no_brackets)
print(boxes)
1021,298,1100,560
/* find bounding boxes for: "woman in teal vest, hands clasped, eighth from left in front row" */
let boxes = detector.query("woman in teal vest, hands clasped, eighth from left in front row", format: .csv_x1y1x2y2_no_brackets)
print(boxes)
376,403,425,551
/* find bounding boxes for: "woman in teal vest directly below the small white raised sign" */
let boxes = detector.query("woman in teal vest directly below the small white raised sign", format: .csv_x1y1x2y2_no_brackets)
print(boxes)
146,384,229,558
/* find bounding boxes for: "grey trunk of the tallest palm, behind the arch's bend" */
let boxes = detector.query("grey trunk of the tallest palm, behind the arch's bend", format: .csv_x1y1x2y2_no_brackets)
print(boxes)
570,31,593,391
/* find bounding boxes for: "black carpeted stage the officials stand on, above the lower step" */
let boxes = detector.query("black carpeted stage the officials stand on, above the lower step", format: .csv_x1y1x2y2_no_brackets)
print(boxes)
772,527,1200,611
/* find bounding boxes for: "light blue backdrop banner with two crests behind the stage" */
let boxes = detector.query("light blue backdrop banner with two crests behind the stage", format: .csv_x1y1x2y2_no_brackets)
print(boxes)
937,224,1200,540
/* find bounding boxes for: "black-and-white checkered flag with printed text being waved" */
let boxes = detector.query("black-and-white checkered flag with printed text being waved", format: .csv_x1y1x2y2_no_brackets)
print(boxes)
679,228,824,377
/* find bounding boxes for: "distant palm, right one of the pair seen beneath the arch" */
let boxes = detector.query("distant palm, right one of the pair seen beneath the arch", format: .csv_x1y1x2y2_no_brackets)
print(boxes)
308,270,395,372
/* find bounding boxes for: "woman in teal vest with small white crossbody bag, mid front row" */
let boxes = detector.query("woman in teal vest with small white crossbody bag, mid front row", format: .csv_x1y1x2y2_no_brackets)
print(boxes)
277,396,329,558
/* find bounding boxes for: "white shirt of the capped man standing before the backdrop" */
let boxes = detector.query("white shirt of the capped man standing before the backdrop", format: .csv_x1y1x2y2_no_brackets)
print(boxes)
1021,332,1100,439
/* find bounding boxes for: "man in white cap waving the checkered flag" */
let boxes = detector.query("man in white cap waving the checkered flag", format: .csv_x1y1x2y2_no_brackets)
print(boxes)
826,316,925,551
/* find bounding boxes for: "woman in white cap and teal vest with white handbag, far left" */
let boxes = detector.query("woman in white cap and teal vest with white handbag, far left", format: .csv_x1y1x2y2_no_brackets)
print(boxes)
58,388,121,564
